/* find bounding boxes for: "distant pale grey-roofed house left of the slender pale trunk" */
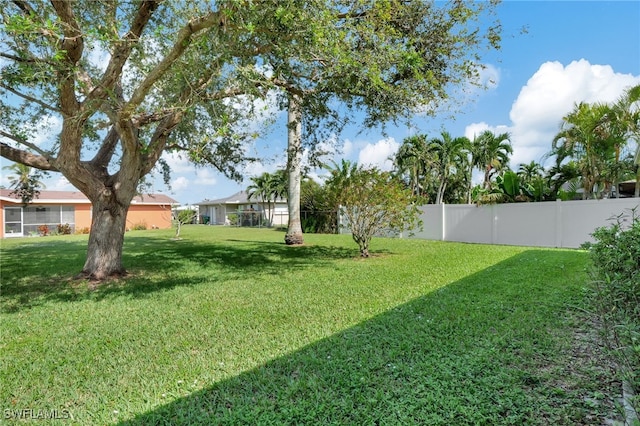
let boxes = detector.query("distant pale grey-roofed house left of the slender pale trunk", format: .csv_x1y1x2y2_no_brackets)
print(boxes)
197,191,289,226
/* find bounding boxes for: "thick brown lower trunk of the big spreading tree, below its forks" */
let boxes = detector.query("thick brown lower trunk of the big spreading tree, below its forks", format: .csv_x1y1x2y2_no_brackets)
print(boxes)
81,197,129,281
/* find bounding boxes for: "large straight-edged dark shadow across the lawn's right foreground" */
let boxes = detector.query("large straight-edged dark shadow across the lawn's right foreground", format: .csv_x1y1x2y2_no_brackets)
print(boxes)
120,251,616,426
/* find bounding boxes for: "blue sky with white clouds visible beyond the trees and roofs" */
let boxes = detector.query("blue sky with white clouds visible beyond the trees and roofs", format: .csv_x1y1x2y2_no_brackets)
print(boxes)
0,0,640,204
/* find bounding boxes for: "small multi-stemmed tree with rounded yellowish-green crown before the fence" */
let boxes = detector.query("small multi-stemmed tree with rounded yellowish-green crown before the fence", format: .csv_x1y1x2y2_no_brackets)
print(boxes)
340,167,422,257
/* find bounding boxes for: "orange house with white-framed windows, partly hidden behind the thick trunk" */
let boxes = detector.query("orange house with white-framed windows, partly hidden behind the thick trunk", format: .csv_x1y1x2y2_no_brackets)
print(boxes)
0,189,178,238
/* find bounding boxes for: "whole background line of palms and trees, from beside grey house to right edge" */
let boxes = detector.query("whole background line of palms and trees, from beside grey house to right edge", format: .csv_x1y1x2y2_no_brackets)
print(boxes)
242,85,640,233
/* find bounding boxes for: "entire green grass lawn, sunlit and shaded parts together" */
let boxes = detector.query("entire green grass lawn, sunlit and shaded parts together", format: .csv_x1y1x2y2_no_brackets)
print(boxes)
0,225,618,425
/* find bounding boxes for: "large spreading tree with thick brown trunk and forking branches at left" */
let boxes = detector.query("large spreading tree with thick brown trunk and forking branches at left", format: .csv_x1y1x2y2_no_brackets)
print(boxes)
0,0,294,280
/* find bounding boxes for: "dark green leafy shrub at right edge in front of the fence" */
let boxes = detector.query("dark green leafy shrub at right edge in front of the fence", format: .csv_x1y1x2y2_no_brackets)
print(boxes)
587,209,640,413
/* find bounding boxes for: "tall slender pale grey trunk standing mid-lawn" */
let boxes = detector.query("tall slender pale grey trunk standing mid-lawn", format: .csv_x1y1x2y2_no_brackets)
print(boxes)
284,93,304,245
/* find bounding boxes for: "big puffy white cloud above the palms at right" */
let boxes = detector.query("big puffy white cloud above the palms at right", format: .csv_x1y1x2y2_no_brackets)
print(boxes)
465,59,640,167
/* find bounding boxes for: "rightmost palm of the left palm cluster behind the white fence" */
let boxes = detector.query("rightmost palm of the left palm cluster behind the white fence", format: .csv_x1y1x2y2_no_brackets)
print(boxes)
471,130,513,189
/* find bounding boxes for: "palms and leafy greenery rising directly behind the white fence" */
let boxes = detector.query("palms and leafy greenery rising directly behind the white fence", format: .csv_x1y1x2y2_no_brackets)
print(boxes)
393,85,640,204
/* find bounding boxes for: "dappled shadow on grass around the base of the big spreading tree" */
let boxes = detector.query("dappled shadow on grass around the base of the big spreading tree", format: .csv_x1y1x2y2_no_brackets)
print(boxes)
0,236,364,313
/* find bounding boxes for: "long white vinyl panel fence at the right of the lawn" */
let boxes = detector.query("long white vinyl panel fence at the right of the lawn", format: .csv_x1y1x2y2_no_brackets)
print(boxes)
413,198,640,248
